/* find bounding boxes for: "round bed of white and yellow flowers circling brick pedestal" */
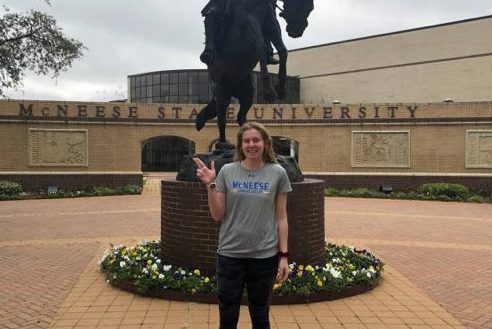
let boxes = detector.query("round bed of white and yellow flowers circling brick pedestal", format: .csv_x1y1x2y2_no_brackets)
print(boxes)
100,241,384,304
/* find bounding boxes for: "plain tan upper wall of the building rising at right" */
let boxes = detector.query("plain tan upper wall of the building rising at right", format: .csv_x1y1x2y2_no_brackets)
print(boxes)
287,16,492,103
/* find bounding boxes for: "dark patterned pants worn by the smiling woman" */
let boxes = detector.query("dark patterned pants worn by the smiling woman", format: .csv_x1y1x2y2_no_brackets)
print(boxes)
217,255,278,329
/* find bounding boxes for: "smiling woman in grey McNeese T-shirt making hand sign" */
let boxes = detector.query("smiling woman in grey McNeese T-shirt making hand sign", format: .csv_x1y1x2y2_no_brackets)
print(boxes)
194,122,292,329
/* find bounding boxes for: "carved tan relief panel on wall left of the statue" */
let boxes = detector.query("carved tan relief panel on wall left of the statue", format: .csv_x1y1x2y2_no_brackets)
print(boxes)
29,129,89,167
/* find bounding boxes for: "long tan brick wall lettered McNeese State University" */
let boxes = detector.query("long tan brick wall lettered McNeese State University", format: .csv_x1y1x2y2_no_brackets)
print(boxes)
0,100,492,190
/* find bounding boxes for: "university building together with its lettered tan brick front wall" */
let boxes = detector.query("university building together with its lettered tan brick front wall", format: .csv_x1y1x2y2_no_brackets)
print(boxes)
0,16,492,192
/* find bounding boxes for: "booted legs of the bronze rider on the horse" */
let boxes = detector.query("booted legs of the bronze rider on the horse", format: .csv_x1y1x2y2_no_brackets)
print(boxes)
200,0,279,65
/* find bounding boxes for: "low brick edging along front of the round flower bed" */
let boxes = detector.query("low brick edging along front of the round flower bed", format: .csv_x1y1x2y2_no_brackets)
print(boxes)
111,277,381,305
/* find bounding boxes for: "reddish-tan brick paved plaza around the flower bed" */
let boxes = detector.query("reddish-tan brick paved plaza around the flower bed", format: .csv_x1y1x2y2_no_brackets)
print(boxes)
0,177,492,329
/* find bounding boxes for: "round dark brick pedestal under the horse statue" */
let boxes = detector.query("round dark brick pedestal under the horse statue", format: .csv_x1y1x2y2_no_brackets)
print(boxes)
161,179,325,274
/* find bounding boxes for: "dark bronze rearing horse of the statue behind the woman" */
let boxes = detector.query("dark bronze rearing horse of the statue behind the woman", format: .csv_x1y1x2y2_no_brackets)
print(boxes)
195,0,314,144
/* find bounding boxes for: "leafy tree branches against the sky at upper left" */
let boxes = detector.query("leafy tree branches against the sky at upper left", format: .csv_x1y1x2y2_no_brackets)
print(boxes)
0,1,86,96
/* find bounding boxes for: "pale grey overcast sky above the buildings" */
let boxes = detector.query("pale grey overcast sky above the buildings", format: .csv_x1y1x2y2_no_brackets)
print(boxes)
0,0,492,101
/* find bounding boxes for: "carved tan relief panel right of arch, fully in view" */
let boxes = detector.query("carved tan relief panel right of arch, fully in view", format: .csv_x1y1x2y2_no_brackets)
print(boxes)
352,131,410,168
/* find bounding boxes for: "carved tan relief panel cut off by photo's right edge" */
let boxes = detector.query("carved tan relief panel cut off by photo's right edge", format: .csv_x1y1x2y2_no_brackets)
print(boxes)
465,130,492,168
